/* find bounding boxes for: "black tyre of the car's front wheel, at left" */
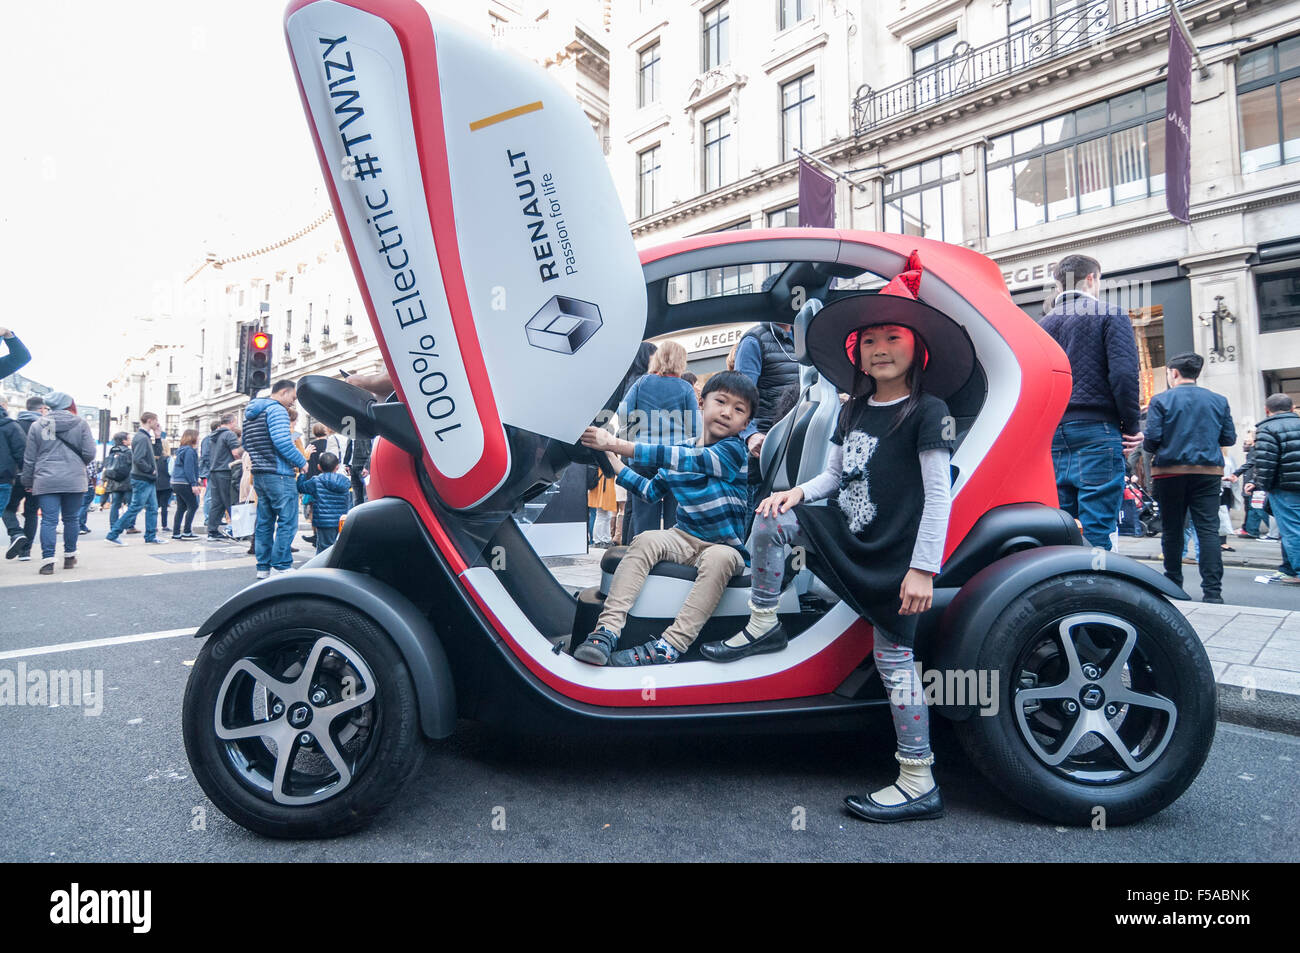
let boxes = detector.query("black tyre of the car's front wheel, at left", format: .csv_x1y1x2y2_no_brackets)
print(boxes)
182,598,424,837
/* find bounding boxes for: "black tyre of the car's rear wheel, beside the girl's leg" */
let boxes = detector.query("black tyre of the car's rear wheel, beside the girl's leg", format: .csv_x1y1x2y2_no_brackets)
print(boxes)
957,572,1217,826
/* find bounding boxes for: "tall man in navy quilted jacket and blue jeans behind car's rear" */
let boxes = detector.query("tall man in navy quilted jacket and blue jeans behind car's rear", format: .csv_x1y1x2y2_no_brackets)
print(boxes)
1041,255,1141,550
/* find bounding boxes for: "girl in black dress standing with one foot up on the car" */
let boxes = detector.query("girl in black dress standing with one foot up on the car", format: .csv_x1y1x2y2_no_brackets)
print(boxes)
702,256,953,822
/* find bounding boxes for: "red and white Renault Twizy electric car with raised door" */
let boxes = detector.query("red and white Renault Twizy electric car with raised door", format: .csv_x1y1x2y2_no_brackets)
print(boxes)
183,0,1216,836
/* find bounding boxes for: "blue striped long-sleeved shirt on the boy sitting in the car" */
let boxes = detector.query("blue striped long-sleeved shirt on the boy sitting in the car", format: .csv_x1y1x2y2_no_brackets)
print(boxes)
618,437,749,563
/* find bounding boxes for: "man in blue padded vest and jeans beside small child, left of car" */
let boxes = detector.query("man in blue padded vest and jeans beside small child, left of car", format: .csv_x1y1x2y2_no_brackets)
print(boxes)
243,381,307,579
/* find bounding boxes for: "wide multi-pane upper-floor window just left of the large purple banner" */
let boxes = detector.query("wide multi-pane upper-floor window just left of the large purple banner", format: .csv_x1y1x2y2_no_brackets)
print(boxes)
982,82,1165,241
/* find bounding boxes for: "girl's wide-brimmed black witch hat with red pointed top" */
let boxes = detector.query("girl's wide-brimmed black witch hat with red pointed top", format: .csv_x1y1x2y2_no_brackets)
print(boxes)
796,252,975,400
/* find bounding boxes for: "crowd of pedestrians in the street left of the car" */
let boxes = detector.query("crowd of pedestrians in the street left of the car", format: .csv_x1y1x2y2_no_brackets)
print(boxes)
0,328,371,579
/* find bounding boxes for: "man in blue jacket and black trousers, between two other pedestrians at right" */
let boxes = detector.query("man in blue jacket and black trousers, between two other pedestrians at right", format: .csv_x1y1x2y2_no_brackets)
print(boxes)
1145,352,1236,603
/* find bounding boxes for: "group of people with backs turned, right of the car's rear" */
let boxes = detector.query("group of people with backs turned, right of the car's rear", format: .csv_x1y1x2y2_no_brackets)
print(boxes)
1043,255,1300,603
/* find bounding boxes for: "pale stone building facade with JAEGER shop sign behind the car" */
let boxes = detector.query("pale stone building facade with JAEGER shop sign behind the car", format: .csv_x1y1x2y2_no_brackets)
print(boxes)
610,0,1300,439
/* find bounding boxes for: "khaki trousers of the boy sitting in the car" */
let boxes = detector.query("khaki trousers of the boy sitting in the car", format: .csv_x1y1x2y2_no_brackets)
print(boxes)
599,527,745,651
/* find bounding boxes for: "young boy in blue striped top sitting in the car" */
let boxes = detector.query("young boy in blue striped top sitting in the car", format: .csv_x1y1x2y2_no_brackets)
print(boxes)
573,371,758,666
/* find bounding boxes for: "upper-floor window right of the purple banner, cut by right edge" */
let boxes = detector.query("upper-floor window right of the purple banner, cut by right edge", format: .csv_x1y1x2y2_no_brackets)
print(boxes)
1236,36,1300,174
